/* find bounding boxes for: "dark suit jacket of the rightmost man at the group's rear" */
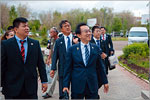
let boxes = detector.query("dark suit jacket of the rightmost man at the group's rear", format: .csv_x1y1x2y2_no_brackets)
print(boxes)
100,34,114,56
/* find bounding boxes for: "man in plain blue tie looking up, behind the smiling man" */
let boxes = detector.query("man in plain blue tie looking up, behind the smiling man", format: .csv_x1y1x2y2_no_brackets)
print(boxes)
50,20,77,99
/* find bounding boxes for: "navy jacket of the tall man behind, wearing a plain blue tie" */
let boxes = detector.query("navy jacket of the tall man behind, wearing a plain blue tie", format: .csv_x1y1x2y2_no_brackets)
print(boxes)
51,36,74,77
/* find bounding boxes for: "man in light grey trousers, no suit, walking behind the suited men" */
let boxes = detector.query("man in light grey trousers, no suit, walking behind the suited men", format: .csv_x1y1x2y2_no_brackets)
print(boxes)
42,27,58,99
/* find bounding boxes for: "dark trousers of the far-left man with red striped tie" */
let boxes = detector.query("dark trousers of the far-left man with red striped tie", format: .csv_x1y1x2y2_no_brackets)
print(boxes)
5,82,38,99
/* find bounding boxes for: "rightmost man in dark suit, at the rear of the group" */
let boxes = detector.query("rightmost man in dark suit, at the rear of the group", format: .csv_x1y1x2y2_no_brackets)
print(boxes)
100,27,114,74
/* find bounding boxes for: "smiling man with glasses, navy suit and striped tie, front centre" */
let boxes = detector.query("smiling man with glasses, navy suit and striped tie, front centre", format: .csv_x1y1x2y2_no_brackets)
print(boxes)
63,23,109,99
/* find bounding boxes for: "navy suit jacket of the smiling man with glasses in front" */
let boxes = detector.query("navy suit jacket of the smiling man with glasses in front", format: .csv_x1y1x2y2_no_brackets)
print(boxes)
63,43,108,94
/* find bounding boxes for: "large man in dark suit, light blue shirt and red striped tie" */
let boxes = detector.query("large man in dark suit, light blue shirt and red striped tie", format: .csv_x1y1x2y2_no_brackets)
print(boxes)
1,17,47,99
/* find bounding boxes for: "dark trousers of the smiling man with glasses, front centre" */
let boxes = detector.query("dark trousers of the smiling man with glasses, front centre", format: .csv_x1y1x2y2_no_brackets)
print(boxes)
71,84,99,100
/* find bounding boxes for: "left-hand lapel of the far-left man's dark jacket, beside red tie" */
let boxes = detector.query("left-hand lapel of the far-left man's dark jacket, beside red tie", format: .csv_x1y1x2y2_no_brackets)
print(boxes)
12,37,24,63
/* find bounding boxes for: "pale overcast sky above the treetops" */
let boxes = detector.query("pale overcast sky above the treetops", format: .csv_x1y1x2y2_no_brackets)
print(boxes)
4,0,149,17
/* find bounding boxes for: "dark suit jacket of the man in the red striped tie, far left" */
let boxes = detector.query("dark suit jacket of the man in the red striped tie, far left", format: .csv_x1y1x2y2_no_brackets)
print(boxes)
1,37,47,96
